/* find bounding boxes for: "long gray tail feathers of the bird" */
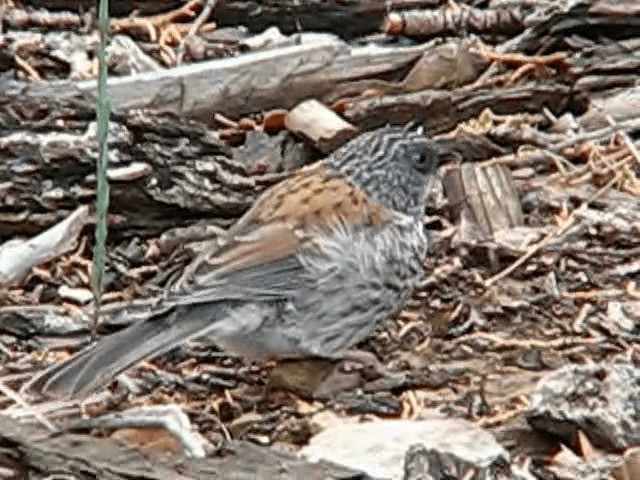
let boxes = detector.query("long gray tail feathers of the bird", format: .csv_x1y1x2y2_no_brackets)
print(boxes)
23,303,223,399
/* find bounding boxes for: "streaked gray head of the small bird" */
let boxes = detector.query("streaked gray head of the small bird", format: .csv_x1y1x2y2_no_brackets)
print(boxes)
326,126,441,217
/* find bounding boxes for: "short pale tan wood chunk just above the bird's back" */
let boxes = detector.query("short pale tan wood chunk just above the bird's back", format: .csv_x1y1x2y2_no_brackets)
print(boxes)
284,100,358,153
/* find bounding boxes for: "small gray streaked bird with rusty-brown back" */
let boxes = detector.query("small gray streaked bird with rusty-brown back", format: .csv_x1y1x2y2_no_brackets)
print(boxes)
23,125,442,399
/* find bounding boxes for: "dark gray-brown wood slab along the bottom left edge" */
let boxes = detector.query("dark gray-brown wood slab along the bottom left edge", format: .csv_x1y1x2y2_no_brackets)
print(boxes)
0,416,368,480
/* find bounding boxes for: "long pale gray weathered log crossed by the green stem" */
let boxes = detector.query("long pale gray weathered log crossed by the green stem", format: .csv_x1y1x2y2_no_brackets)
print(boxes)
0,34,438,121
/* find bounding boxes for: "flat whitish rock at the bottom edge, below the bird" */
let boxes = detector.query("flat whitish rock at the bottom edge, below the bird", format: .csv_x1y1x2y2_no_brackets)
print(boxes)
301,419,511,480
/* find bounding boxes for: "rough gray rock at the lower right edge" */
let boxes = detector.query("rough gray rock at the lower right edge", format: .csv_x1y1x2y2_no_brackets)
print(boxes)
527,363,640,449
